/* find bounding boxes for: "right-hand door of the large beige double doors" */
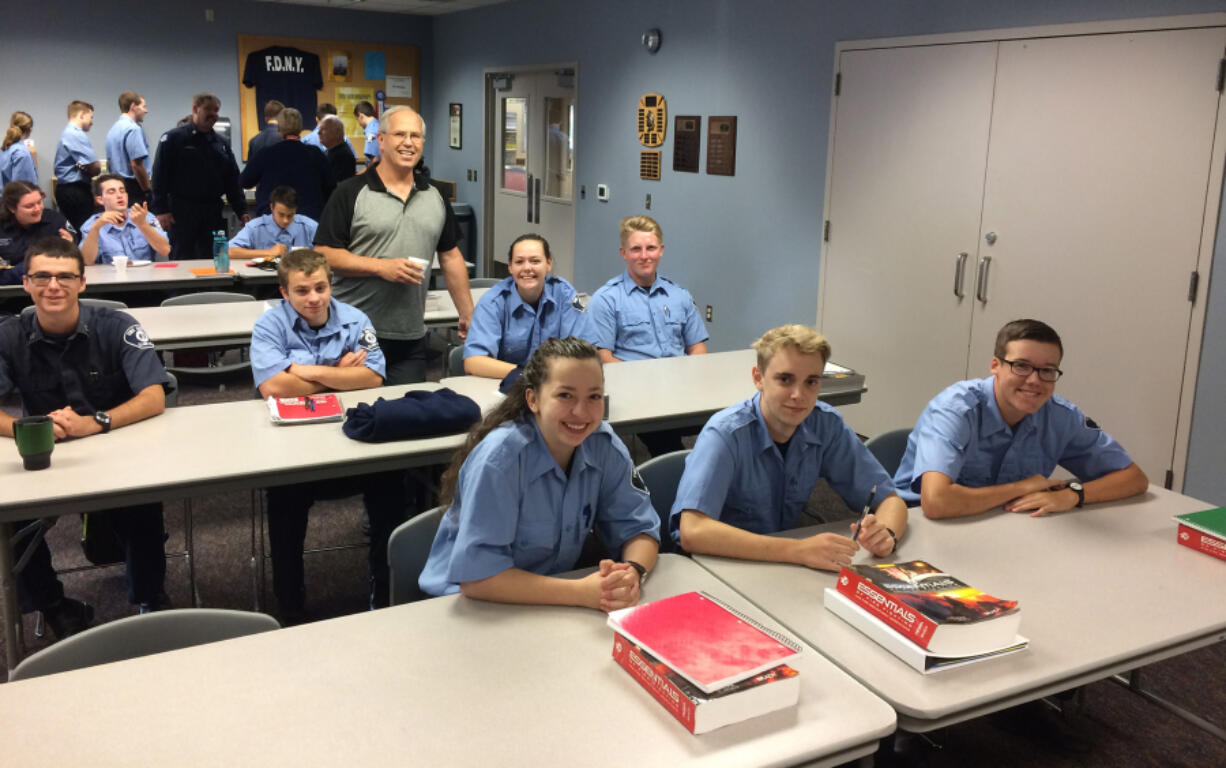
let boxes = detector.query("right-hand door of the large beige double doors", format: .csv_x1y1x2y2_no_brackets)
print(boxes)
966,28,1226,483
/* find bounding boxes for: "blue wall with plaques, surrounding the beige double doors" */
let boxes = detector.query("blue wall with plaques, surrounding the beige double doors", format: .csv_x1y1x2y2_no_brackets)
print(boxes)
427,0,1226,504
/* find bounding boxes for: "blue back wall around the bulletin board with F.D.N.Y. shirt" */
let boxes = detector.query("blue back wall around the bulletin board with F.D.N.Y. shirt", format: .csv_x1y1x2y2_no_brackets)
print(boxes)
0,0,433,181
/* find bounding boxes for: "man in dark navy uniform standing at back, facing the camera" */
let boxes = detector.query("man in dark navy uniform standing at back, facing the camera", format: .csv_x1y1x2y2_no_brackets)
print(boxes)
151,93,249,260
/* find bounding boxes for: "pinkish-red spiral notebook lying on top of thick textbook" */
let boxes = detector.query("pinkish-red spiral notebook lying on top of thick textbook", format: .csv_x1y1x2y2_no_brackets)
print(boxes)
608,593,801,693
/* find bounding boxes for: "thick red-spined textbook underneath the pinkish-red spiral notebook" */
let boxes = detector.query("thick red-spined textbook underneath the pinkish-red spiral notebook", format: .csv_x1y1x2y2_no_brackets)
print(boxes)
613,633,801,734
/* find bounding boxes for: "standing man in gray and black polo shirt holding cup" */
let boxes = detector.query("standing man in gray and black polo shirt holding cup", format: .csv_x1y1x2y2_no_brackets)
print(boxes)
315,107,472,384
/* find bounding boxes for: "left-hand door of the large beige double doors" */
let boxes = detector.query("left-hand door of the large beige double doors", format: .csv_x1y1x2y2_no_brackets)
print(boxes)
818,43,997,434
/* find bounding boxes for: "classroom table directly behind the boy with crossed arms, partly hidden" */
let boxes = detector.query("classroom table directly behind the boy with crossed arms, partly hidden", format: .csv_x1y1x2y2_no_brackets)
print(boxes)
125,288,488,350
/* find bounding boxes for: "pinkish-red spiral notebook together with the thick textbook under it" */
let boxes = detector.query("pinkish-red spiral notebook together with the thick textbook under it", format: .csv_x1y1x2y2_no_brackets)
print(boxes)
608,593,801,734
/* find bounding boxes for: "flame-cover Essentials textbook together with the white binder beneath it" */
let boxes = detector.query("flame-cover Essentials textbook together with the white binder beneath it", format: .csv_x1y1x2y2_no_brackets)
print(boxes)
825,559,1027,675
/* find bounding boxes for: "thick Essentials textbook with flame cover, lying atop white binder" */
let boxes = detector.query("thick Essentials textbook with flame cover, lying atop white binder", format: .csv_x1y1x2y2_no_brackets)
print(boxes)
837,559,1021,656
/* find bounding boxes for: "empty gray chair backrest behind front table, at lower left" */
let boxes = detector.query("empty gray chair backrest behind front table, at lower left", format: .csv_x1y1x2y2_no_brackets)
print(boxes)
9,609,281,681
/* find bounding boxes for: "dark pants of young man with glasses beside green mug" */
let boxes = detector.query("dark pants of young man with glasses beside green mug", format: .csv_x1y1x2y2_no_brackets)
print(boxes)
13,503,166,613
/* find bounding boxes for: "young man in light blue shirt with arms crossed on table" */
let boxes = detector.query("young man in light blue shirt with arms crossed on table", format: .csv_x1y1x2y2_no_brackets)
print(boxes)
251,249,408,623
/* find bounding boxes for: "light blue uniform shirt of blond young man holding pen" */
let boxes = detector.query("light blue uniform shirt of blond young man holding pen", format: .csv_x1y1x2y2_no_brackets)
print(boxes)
668,394,891,545
